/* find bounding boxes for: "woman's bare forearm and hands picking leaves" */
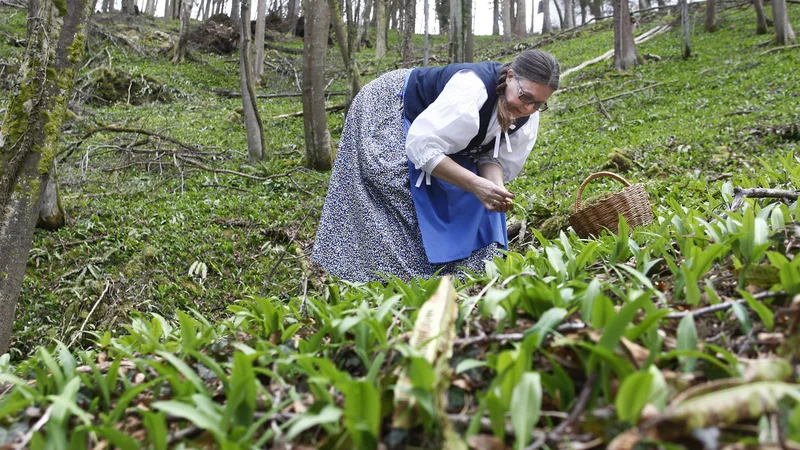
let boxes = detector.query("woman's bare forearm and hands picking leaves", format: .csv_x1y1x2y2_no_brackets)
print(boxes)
431,156,514,212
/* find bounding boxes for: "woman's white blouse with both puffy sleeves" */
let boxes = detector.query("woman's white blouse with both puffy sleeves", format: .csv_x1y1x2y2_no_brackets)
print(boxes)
406,70,539,181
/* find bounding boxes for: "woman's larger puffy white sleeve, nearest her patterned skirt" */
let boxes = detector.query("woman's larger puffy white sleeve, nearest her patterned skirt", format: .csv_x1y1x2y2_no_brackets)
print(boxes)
406,70,488,173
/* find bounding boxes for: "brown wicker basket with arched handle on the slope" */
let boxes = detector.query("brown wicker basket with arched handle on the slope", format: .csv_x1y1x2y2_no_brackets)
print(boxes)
569,172,653,238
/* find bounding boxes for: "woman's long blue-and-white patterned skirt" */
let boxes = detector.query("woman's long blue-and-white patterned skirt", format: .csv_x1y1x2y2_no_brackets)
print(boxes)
312,69,497,281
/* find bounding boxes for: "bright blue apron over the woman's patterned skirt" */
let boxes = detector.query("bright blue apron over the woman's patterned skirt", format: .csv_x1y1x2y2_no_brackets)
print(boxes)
404,117,508,264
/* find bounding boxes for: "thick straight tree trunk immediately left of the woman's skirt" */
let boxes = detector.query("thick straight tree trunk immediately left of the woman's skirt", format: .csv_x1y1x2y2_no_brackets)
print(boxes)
303,0,332,171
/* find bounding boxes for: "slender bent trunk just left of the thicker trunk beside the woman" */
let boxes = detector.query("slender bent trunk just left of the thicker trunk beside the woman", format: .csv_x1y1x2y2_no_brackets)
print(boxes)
239,0,268,162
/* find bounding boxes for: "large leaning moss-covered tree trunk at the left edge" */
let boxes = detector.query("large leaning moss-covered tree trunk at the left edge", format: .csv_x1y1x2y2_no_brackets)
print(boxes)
0,0,91,353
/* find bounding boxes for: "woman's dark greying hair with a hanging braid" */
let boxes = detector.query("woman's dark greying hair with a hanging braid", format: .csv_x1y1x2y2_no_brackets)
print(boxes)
497,50,561,131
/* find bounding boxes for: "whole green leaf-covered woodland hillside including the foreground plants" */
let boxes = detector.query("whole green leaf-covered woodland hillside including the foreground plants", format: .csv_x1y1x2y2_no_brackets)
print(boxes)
0,3,800,449
